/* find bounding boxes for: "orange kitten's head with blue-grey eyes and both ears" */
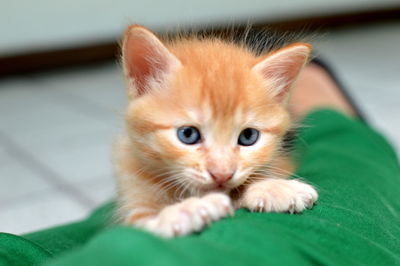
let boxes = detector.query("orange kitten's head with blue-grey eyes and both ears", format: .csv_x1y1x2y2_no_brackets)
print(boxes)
122,26,311,196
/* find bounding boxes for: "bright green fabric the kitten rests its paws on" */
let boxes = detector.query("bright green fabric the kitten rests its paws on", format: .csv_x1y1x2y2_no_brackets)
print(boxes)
0,110,400,265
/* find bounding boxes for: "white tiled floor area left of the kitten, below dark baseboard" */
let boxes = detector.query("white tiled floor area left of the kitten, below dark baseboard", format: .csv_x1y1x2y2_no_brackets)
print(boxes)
0,64,125,233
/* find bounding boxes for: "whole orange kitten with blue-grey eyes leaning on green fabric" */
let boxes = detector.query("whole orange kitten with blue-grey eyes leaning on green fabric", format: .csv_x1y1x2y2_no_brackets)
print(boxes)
114,25,318,237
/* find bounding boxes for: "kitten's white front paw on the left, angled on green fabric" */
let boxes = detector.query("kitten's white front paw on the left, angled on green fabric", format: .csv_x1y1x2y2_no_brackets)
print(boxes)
144,193,233,237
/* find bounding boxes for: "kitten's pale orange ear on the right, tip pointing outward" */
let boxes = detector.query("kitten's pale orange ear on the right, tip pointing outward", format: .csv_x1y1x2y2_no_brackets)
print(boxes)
253,43,311,102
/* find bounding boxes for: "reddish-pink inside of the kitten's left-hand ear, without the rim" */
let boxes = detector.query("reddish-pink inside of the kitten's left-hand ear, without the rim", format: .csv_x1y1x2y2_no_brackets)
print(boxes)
124,34,168,96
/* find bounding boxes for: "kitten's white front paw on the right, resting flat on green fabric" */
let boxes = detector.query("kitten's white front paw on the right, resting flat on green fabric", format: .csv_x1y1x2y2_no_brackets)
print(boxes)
241,179,318,213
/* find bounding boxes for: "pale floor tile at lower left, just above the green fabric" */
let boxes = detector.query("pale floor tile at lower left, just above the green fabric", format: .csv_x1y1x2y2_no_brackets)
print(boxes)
0,192,88,234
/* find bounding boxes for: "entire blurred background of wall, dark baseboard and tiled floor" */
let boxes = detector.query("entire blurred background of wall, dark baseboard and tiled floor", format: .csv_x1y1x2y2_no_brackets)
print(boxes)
0,0,400,234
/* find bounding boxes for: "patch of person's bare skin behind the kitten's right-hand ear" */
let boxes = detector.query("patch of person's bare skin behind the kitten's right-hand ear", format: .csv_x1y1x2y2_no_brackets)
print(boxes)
289,63,356,119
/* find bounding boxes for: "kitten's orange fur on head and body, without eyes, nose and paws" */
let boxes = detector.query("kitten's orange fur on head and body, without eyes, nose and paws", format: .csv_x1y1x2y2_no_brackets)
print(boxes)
114,25,311,229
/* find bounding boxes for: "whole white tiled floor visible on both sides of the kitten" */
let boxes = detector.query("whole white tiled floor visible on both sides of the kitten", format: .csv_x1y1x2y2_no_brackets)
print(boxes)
0,24,400,234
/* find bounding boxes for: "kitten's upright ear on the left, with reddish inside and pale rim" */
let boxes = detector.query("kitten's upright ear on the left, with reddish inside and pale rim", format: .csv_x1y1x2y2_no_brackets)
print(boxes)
122,25,181,98
